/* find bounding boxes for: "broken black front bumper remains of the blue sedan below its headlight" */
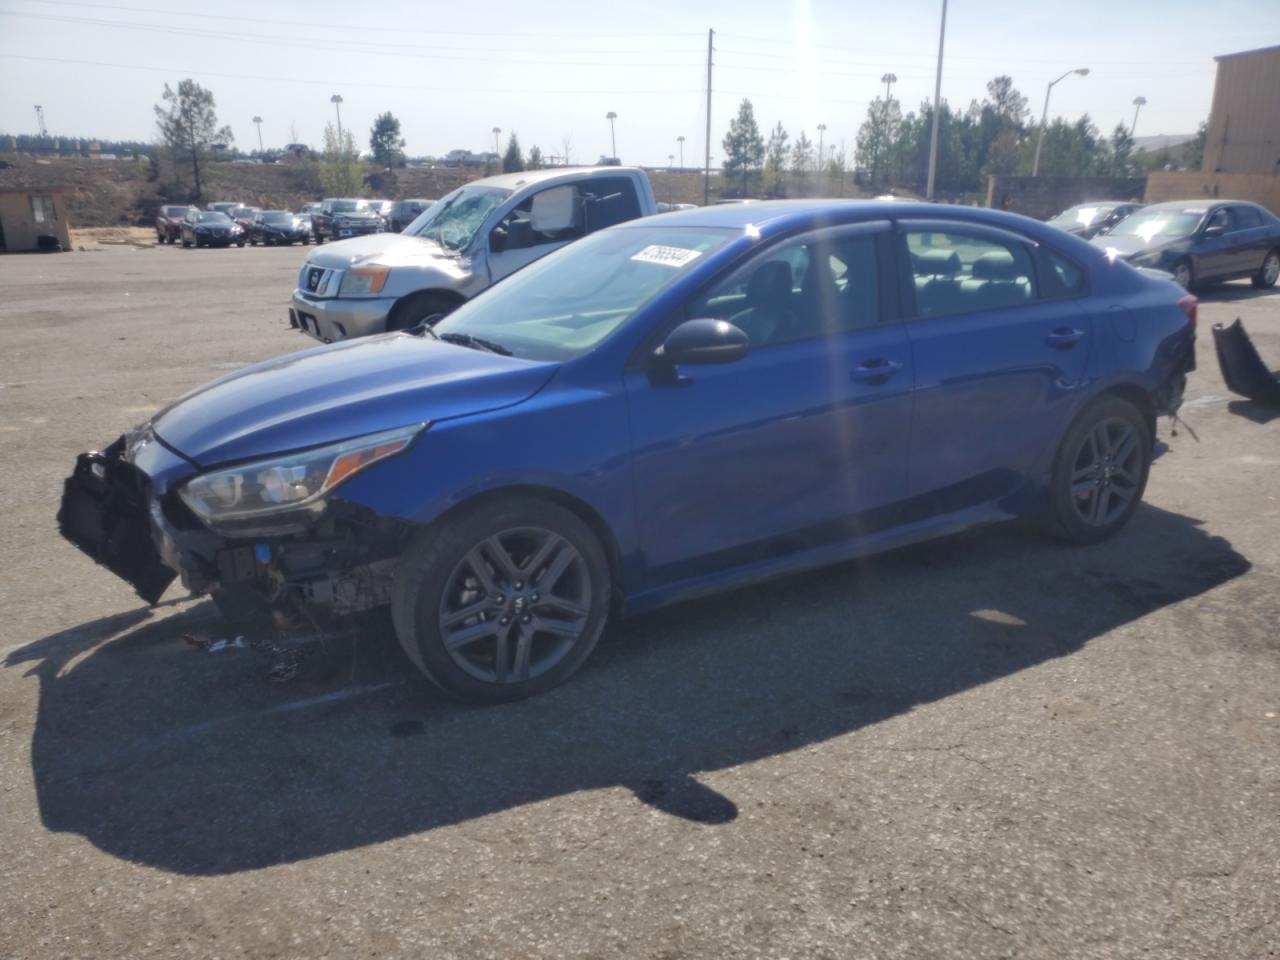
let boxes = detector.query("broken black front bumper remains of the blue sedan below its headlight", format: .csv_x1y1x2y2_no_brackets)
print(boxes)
58,435,410,613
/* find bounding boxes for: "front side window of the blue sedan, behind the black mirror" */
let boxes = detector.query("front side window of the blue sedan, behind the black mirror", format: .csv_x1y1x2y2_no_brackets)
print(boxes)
689,233,879,347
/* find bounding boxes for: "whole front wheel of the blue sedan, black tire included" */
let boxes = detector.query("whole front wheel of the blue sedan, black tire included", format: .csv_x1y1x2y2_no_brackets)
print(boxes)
392,497,612,703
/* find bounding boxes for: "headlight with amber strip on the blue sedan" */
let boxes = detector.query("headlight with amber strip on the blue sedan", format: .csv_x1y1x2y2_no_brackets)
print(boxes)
178,424,426,536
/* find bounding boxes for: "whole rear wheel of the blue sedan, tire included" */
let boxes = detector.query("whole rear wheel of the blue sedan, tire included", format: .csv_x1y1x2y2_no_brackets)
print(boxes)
1041,396,1155,543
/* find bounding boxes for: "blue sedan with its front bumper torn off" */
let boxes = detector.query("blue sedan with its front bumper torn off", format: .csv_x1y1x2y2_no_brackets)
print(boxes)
59,201,1196,701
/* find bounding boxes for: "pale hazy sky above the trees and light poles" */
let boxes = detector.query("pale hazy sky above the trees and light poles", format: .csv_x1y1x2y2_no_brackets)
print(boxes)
0,0,1280,166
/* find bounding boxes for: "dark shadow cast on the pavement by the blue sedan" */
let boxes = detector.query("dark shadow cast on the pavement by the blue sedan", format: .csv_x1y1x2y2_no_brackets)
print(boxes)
6,506,1249,874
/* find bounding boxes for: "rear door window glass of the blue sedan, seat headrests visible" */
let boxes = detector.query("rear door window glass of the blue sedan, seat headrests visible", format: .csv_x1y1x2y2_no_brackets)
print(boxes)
906,229,1037,317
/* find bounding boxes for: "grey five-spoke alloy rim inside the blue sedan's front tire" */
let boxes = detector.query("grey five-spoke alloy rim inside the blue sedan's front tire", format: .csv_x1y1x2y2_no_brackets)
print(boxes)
439,527,591,684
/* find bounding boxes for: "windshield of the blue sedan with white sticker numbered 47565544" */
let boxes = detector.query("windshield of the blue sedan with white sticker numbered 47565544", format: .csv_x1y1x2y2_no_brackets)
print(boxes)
434,227,741,361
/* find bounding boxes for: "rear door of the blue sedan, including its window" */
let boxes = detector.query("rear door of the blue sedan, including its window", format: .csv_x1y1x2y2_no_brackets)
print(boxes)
899,220,1093,513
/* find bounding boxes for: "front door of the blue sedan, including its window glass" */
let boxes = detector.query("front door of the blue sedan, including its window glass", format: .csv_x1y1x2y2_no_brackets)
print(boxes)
626,224,911,588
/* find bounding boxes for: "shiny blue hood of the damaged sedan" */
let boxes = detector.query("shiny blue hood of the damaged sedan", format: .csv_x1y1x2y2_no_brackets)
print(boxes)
152,333,558,467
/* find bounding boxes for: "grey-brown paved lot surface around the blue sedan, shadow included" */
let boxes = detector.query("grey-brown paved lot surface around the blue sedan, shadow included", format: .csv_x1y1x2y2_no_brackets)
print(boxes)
0,247,1280,960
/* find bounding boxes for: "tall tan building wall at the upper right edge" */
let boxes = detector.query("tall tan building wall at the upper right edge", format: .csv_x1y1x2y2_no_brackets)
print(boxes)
1202,47,1280,177
